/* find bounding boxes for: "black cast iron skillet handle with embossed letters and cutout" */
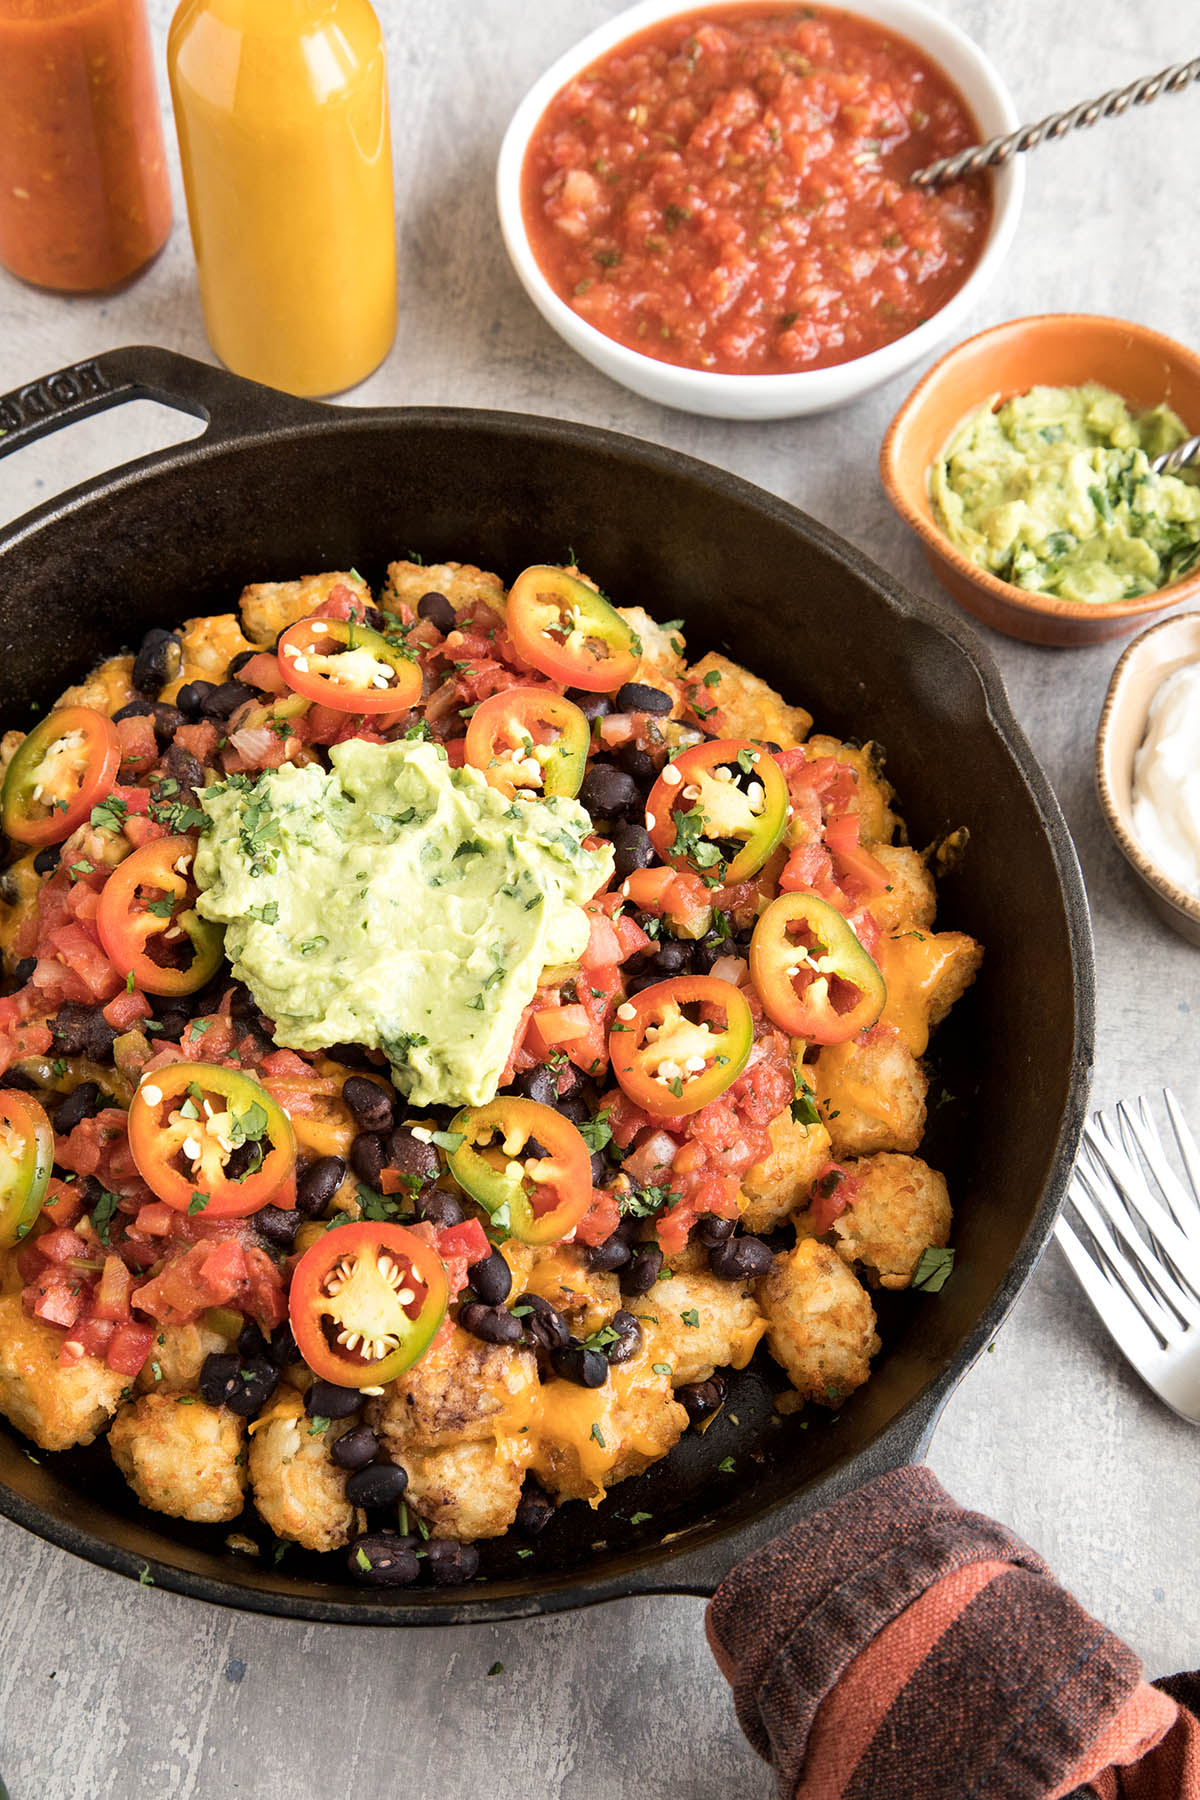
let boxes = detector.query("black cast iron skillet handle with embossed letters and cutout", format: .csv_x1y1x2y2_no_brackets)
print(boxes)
0,344,324,463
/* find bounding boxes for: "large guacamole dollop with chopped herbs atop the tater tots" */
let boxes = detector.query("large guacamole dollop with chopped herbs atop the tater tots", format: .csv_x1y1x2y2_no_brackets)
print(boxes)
194,740,612,1105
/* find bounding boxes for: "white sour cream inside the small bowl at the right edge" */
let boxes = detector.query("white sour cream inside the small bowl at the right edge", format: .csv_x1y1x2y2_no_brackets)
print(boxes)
1133,662,1200,898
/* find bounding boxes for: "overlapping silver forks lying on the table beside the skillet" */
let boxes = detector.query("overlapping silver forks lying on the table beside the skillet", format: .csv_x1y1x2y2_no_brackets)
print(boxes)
1054,1087,1200,1426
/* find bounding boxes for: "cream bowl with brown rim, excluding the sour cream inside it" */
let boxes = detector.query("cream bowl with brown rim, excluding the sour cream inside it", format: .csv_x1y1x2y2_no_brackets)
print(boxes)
1096,612,1200,943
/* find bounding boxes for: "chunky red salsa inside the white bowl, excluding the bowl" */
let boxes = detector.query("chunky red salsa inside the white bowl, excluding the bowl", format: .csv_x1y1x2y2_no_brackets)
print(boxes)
522,5,991,374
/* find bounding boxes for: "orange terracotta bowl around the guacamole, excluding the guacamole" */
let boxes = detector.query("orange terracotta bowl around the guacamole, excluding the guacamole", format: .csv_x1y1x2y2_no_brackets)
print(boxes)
880,313,1200,644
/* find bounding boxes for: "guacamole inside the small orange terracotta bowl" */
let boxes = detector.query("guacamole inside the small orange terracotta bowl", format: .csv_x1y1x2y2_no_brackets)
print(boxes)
930,382,1200,605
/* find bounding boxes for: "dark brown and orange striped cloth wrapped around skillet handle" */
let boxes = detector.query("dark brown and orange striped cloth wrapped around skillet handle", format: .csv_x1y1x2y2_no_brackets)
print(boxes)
707,1469,1200,1800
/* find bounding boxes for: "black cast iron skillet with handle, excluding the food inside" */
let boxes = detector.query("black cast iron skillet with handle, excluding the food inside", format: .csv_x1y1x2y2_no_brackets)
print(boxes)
0,349,1092,1625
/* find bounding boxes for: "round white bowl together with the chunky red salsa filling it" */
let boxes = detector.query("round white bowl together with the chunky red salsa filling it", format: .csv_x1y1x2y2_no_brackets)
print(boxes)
497,0,1024,419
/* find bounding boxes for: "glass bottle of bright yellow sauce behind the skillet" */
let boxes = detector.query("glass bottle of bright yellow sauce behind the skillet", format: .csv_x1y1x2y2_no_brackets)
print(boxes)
167,0,396,394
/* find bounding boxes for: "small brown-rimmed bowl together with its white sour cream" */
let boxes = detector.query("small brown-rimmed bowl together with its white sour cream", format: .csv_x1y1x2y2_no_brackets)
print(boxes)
1096,612,1200,945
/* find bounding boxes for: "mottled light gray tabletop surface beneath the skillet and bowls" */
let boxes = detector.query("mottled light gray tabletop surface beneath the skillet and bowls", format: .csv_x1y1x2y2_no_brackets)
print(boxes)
0,0,1200,1800
